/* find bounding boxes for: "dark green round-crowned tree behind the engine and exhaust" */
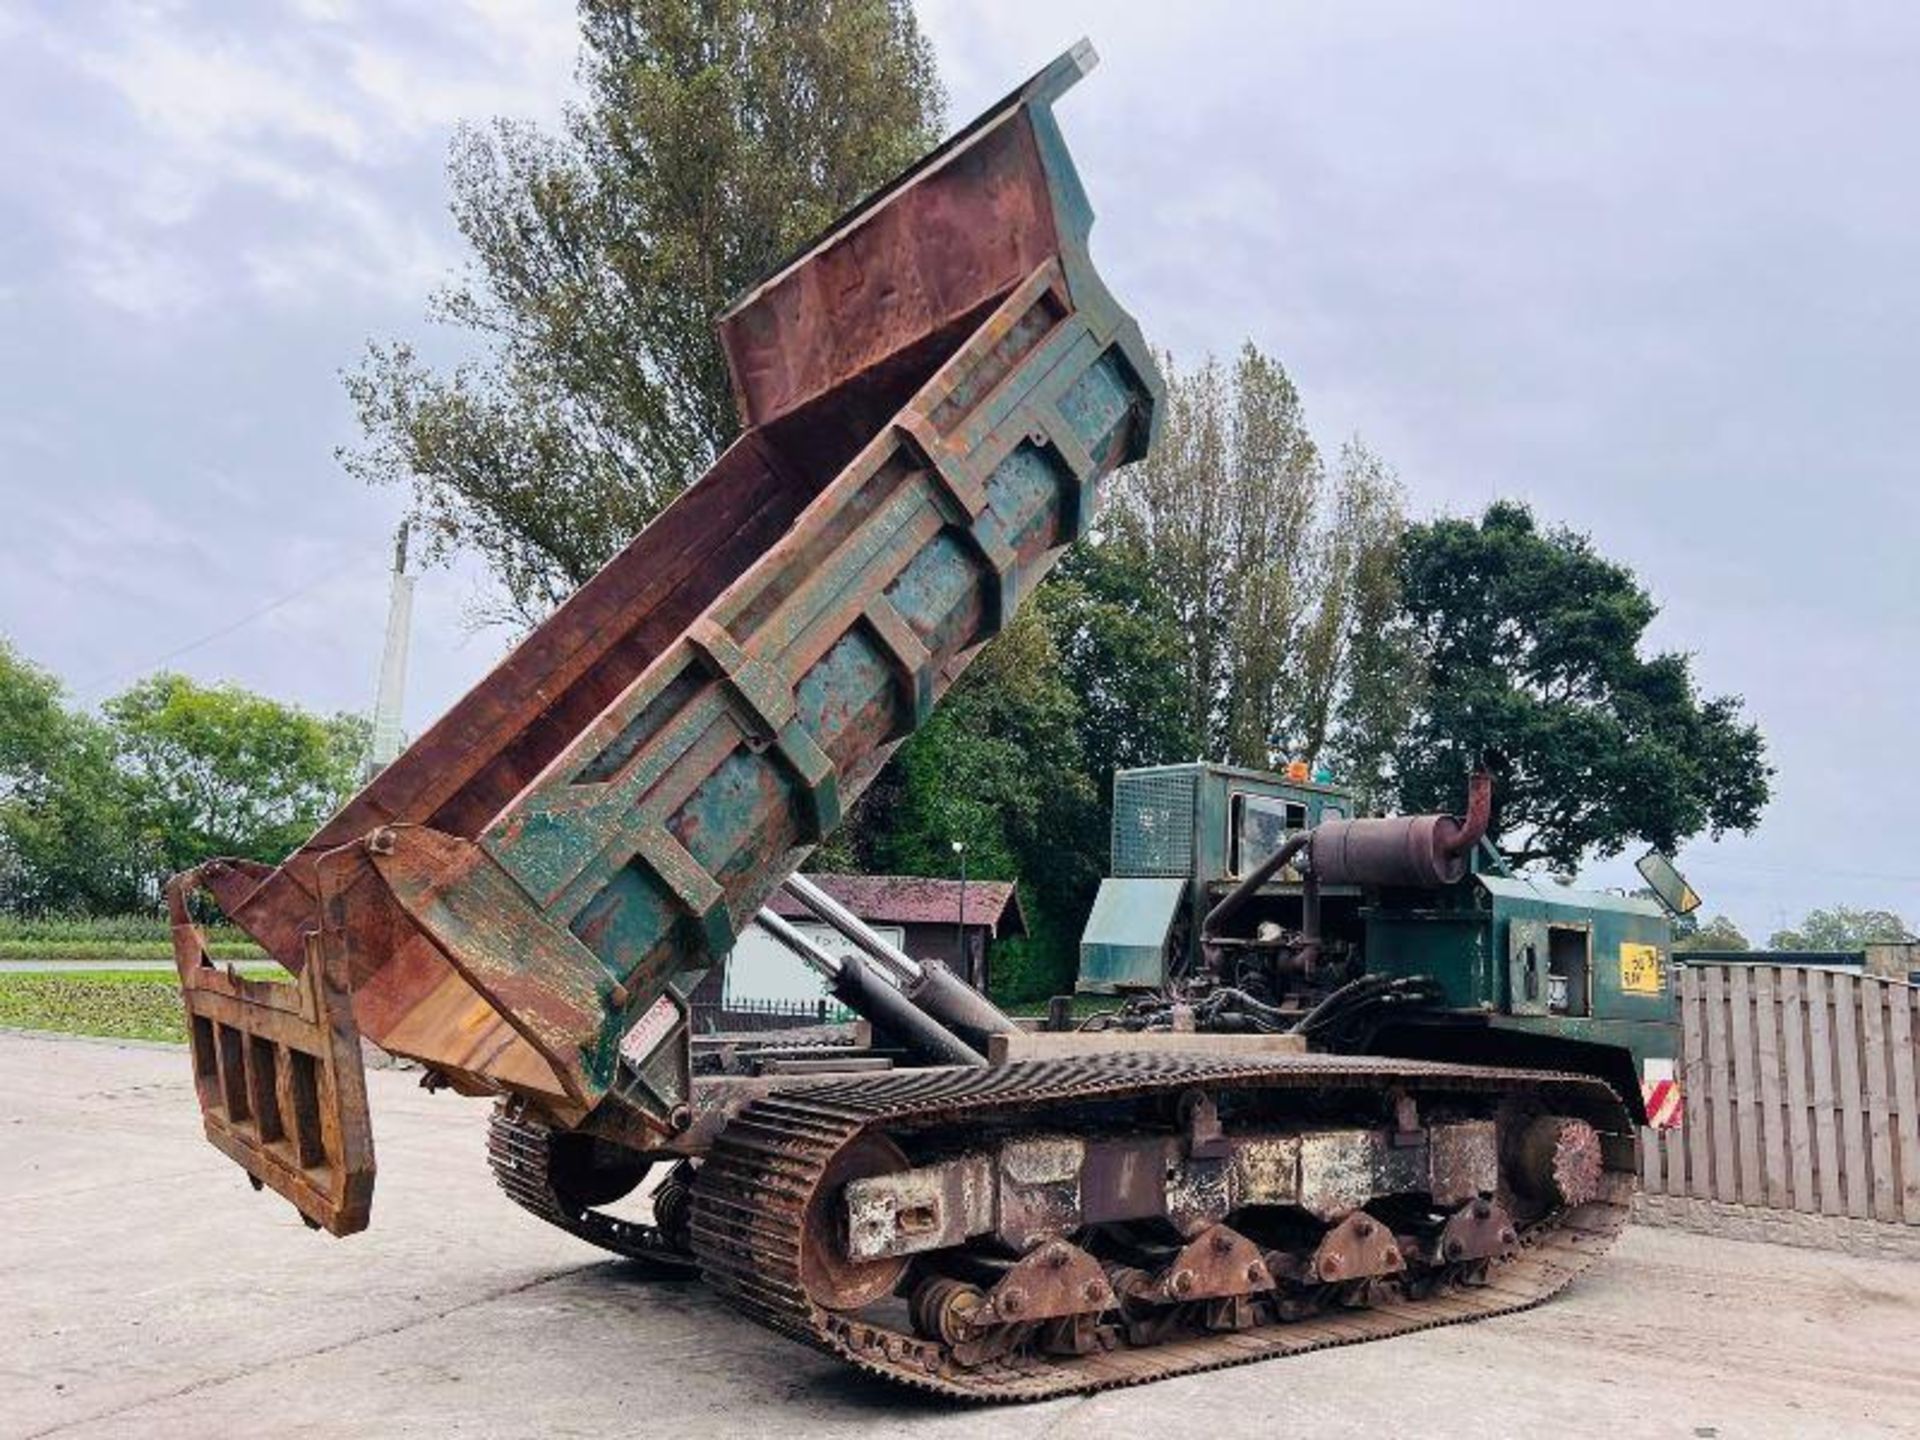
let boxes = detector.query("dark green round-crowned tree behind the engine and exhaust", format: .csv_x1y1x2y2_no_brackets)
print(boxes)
1390,501,1772,870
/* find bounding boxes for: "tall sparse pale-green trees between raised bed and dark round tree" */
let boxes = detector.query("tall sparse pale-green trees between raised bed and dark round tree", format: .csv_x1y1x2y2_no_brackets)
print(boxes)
1102,344,1402,766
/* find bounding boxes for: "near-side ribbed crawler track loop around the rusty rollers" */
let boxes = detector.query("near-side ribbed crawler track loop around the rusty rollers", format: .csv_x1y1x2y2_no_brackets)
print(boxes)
693,1054,1634,1402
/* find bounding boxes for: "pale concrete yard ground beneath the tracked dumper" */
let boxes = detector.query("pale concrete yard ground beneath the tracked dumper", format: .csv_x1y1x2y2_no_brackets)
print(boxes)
0,1033,1920,1440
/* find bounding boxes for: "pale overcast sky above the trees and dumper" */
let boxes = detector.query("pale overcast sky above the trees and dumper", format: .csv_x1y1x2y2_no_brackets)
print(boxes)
0,0,1920,939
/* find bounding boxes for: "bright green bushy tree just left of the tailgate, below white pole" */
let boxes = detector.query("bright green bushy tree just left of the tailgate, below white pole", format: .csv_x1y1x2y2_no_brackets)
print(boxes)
104,674,369,890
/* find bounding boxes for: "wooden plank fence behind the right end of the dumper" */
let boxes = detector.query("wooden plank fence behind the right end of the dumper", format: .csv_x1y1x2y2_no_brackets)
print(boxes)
1642,964,1920,1225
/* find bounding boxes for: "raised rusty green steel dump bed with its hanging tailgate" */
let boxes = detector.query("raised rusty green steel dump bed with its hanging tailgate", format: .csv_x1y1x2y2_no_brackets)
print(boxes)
171,44,1160,1233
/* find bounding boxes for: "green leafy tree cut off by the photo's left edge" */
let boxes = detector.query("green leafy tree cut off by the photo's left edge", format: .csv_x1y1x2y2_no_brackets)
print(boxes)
0,639,152,914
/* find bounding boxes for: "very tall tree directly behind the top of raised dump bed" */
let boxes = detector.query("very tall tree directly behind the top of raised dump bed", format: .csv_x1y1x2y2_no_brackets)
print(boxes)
344,0,945,622
